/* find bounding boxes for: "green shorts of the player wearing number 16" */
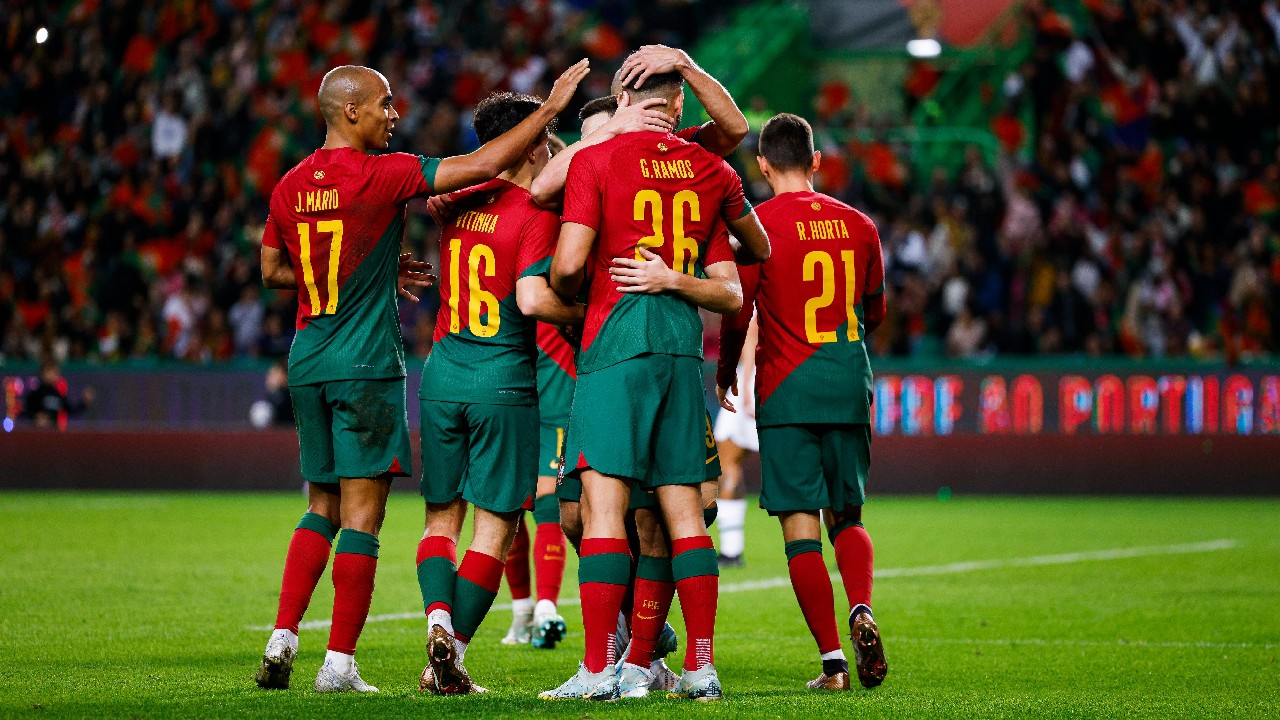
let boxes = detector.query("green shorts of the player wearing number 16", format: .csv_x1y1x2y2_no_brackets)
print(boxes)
419,400,538,512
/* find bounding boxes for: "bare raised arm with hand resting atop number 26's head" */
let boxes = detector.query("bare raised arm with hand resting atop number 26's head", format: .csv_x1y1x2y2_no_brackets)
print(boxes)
620,45,749,156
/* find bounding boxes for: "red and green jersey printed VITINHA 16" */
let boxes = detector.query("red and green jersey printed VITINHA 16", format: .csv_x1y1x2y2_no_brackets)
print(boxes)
419,179,559,405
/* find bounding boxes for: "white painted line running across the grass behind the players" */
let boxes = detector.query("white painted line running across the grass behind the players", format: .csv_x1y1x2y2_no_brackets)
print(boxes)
247,538,1240,632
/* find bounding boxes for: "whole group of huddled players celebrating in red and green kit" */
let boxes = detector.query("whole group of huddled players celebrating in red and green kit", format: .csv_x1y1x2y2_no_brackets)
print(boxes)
256,46,887,701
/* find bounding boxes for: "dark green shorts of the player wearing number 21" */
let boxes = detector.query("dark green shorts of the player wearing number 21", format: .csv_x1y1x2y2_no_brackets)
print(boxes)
759,424,872,515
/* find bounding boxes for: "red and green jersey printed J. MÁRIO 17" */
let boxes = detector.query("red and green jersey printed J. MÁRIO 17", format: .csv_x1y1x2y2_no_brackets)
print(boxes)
262,142,440,386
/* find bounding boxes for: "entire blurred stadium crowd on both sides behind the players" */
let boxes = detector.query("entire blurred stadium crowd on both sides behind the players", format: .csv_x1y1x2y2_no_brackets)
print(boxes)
0,0,1280,361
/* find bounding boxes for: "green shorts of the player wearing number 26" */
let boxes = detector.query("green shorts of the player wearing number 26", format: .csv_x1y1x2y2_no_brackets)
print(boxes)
564,354,707,488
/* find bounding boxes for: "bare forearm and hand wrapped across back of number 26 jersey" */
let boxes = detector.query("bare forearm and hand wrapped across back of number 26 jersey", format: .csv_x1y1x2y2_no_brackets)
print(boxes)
609,247,742,314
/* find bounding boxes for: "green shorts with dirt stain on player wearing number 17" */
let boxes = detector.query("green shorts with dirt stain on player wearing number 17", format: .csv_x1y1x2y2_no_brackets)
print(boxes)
289,378,413,484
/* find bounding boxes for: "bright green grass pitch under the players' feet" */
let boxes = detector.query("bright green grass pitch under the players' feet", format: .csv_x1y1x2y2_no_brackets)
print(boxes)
0,493,1280,720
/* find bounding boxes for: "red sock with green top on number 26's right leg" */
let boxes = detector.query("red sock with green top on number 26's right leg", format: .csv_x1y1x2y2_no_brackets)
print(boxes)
671,536,719,670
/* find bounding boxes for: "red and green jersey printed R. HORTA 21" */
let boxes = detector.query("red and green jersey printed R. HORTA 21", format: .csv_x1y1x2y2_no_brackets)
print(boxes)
717,191,884,427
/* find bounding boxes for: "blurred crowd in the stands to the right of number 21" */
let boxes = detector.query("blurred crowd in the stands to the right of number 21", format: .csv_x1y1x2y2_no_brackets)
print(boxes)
798,0,1280,361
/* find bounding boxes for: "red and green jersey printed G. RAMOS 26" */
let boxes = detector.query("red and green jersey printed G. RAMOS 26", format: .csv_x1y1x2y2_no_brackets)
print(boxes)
562,132,751,373
